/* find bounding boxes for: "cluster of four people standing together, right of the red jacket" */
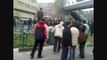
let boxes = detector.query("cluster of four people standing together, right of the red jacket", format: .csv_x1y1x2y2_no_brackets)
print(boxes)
52,18,89,60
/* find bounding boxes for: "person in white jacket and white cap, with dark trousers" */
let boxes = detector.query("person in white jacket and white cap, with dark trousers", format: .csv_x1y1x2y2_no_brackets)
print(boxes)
52,22,64,53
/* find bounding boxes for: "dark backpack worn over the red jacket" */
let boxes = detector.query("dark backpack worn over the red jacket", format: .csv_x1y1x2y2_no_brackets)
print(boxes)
35,26,45,40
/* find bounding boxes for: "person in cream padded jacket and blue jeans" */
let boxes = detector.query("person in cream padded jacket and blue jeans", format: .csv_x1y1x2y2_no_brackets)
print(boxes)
69,19,79,60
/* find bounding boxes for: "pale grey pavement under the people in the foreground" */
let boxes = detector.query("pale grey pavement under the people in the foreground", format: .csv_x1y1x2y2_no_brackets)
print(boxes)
14,46,93,60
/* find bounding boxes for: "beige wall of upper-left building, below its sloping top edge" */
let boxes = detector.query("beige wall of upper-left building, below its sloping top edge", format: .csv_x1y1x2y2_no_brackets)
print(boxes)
13,0,37,18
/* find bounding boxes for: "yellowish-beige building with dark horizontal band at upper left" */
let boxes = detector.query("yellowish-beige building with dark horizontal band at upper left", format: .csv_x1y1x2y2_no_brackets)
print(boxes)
13,0,37,19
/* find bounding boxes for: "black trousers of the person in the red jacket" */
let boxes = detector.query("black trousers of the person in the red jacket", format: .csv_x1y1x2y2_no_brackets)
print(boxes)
31,40,44,57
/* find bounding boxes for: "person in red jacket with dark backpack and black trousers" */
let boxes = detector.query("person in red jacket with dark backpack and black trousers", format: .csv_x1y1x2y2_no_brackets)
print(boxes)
30,18,48,59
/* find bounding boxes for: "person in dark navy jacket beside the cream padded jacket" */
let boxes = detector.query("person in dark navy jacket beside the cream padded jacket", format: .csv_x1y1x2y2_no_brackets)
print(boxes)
61,20,72,60
